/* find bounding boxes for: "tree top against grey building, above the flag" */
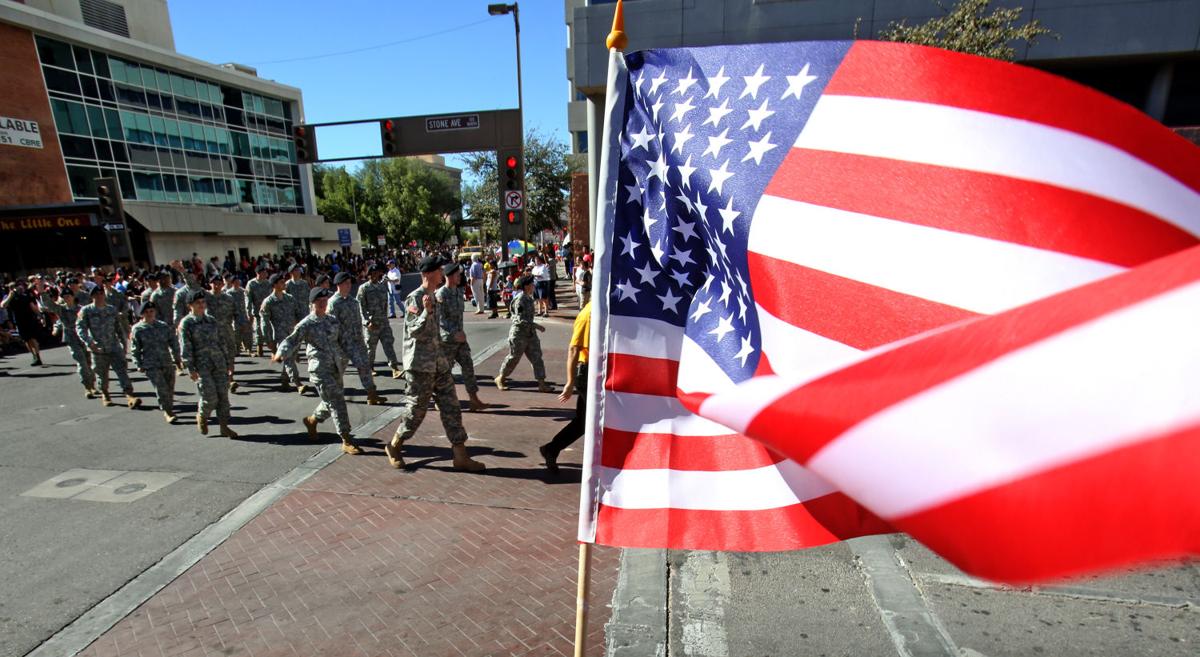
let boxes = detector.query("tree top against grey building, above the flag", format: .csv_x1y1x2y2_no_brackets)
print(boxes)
880,0,1058,61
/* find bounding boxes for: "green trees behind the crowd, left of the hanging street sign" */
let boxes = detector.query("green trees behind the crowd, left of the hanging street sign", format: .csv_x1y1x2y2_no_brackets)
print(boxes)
313,157,462,245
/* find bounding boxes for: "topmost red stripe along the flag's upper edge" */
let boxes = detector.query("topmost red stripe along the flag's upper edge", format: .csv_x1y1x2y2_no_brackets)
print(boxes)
824,41,1200,191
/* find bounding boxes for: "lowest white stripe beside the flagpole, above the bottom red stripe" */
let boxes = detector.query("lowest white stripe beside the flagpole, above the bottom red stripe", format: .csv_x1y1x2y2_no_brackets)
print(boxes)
600,460,836,511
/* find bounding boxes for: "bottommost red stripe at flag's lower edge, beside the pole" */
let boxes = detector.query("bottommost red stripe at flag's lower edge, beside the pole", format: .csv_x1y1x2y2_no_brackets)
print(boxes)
596,493,895,551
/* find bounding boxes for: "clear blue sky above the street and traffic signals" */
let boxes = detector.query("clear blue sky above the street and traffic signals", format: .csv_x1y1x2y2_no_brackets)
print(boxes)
168,0,570,172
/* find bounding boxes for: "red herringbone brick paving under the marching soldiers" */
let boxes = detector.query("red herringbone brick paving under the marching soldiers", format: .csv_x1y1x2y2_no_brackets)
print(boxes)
82,313,619,657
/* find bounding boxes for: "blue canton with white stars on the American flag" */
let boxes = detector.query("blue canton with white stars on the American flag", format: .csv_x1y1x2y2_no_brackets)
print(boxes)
610,42,850,381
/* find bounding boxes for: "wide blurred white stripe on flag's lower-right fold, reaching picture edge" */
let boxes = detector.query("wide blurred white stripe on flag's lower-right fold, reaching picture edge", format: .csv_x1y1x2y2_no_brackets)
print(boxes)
809,276,1200,518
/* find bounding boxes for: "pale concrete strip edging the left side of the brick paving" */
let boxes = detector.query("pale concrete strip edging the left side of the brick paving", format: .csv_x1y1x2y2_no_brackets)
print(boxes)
25,338,508,657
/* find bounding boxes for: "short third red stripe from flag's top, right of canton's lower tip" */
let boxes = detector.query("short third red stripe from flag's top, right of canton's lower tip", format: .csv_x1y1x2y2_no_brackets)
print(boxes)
746,252,978,349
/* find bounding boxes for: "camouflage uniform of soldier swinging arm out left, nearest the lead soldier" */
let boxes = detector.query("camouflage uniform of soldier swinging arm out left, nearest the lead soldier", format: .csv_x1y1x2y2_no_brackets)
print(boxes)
275,313,350,435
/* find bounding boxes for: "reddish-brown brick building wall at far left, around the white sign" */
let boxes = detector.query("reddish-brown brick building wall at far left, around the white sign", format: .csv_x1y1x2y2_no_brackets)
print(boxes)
0,23,72,205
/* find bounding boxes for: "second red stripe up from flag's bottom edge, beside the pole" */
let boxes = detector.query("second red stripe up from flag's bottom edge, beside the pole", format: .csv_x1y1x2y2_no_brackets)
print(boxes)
600,427,784,472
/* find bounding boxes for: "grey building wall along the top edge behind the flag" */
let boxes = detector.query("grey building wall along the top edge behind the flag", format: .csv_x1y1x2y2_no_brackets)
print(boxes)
565,0,1200,95
